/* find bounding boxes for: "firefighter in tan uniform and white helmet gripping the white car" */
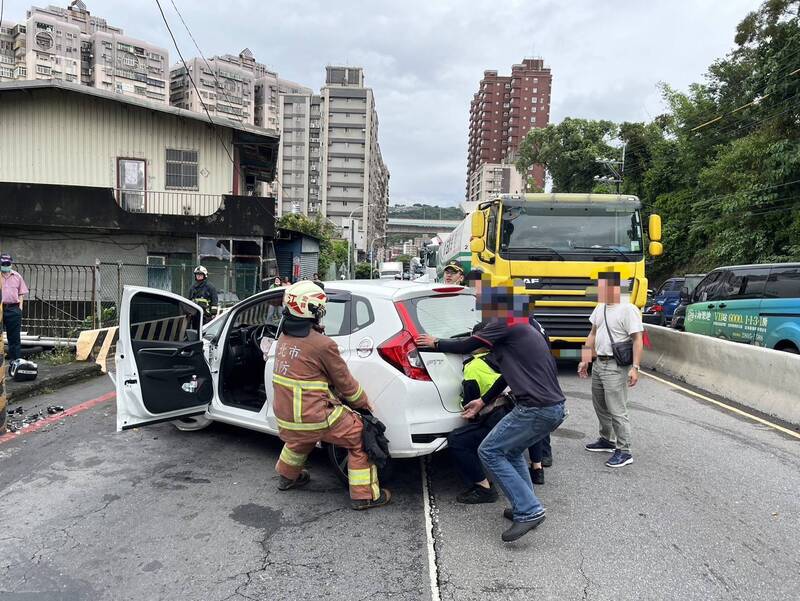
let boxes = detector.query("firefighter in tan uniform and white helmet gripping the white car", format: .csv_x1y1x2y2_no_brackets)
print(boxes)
272,280,391,509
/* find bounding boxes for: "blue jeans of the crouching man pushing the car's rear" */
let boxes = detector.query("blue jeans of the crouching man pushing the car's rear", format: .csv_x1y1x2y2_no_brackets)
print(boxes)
478,402,564,522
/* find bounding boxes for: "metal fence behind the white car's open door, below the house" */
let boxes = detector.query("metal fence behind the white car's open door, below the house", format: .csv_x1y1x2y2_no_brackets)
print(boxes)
15,262,261,339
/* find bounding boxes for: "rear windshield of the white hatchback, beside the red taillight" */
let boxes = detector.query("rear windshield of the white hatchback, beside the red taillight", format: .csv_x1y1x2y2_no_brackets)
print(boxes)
403,294,481,338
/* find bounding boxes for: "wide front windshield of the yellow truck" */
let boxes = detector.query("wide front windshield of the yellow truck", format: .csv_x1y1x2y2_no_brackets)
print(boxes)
500,204,643,262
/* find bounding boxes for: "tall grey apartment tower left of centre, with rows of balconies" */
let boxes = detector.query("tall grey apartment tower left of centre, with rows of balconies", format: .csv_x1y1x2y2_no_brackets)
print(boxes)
276,66,389,252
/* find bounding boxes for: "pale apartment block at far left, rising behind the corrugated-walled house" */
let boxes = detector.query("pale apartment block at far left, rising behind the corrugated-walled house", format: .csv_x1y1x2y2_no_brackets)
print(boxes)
0,0,169,104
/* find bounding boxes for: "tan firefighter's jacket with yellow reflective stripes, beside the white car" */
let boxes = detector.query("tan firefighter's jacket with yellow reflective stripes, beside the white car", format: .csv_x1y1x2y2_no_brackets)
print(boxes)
272,329,367,432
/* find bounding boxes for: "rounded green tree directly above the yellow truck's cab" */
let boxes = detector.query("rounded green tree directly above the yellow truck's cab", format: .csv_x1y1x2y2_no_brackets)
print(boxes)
516,117,619,192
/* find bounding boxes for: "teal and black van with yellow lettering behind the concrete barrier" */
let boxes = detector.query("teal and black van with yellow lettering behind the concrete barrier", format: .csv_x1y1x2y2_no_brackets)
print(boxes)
686,263,800,353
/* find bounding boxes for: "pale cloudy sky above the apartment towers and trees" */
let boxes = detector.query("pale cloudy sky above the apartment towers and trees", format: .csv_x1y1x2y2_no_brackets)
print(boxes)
4,0,760,206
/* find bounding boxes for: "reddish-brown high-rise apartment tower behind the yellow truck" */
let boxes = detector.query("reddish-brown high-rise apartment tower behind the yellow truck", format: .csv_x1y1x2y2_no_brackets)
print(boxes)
466,58,552,201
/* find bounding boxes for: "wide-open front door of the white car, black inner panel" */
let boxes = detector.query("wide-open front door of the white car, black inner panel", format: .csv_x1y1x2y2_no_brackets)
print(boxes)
116,286,214,431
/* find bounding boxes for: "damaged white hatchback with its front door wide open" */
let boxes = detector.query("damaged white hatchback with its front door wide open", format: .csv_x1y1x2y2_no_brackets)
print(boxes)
116,280,480,477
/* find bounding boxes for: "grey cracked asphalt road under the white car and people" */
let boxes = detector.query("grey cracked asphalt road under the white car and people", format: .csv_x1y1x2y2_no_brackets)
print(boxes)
0,370,800,601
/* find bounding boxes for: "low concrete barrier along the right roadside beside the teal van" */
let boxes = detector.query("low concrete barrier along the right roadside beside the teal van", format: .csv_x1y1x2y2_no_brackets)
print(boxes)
642,325,800,425
